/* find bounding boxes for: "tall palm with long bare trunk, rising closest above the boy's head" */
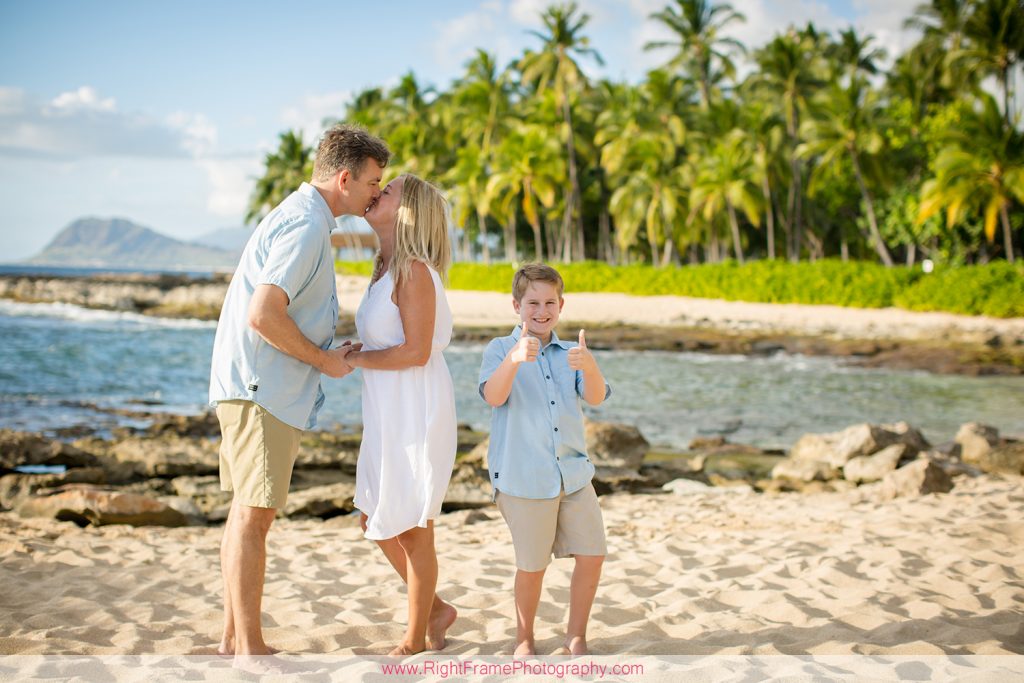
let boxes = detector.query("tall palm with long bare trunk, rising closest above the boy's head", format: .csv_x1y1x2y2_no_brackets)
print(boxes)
518,2,604,260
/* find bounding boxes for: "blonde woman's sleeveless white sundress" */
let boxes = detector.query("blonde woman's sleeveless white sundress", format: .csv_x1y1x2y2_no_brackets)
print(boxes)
355,266,458,541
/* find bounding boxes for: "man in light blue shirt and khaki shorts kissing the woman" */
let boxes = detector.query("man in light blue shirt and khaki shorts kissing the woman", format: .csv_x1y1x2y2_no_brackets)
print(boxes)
210,126,390,664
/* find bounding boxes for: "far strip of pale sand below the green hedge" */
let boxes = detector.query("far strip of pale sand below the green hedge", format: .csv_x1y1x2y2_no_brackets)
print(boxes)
338,275,1024,343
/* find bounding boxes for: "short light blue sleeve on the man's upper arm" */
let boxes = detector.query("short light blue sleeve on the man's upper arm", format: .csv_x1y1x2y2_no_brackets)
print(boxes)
256,217,324,303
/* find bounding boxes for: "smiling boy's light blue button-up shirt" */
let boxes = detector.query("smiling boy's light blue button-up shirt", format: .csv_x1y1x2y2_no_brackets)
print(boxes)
479,326,611,499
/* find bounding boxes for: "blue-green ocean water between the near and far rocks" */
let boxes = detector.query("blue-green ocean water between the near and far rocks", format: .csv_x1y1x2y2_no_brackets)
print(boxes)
0,301,1024,449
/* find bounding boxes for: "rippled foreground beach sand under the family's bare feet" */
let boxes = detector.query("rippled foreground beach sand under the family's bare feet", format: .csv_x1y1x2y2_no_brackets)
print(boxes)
0,477,1024,655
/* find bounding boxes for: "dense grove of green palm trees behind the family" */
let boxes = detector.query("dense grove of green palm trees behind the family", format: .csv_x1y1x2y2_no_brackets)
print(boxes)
250,0,1024,270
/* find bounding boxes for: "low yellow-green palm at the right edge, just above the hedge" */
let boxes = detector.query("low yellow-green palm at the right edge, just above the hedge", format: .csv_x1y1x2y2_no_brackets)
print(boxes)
918,94,1024,262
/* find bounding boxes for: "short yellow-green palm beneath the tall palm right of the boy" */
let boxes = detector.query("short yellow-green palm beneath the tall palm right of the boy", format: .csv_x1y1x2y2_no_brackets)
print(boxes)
690,128,761,263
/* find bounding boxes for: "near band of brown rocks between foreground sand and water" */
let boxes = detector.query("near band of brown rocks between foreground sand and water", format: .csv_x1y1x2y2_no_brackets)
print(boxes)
0,411,1024,526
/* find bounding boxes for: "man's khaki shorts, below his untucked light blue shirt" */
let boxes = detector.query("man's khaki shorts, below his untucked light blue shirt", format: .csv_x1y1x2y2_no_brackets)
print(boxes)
217,400,302,509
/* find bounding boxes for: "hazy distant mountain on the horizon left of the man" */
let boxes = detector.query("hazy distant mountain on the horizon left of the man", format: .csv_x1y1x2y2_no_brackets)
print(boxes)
26,218,239,270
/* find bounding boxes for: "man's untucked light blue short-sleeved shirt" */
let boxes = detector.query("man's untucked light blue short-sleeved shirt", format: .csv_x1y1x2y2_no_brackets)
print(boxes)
210,182,338,429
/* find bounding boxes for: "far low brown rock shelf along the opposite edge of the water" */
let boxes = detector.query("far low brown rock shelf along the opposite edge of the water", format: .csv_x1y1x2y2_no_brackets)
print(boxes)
0,274,1024,376
